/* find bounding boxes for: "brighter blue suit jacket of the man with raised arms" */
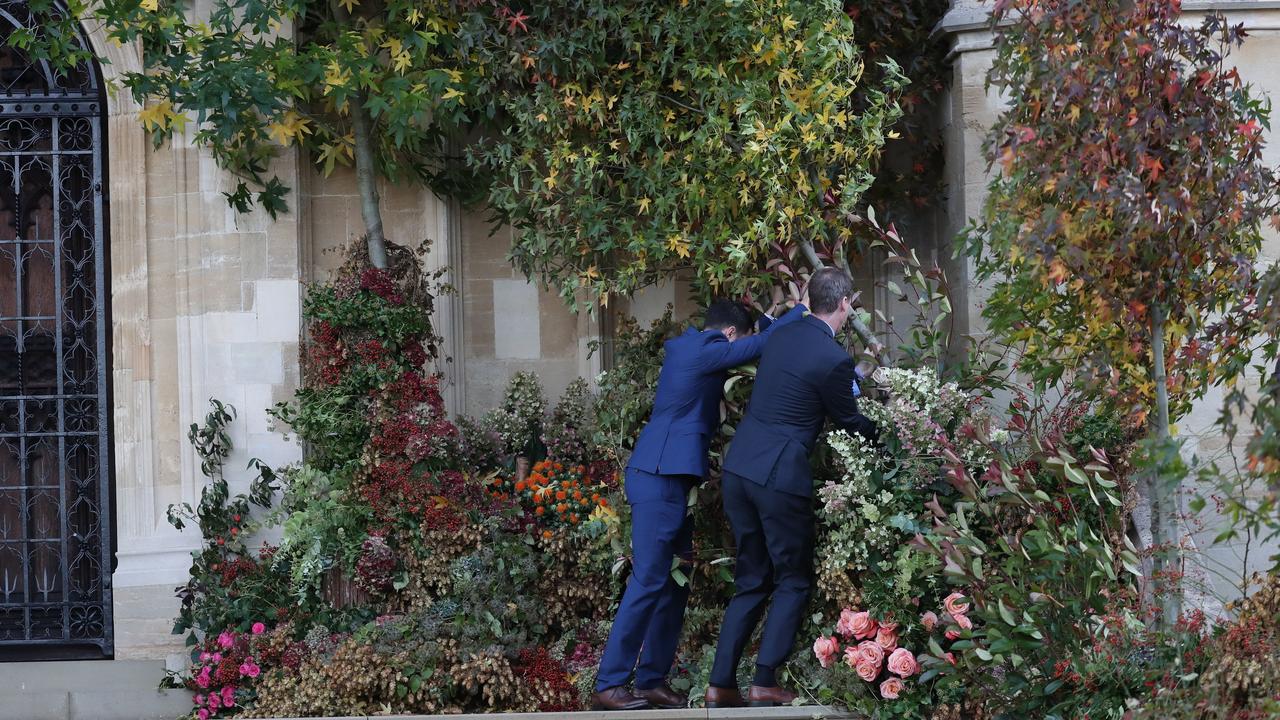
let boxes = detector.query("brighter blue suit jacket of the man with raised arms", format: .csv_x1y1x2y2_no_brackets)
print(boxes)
627,305,806,478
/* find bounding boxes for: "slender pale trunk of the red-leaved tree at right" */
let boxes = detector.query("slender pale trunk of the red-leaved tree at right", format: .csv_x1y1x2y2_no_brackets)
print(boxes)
1149,304,1183,628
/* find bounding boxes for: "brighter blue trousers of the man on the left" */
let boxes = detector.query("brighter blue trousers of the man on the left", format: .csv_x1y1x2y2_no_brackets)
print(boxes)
595,468,698,691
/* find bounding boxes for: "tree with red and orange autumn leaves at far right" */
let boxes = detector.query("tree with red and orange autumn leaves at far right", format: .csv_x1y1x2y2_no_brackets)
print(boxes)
969,0,1275,621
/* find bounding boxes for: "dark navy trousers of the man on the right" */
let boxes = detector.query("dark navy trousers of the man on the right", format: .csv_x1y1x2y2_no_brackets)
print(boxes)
710,473,814,688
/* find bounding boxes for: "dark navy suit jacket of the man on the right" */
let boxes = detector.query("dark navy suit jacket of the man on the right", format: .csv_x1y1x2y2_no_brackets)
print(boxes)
724,315,877,497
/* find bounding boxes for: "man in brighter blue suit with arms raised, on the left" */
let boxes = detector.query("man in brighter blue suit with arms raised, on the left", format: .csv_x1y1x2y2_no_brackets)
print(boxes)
591,293,805,710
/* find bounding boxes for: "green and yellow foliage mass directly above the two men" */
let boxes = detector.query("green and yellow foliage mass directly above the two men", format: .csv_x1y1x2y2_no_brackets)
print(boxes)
471,0,904,304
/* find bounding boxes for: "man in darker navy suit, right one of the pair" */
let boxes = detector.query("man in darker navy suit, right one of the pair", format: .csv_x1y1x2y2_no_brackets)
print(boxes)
707,268,877,707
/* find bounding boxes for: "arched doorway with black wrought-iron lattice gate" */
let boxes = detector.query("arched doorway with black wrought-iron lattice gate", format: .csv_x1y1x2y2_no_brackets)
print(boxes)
0,0,113,660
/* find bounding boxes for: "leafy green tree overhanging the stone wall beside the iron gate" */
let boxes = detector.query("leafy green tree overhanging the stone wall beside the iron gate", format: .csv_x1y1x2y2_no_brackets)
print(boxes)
16,0,494,268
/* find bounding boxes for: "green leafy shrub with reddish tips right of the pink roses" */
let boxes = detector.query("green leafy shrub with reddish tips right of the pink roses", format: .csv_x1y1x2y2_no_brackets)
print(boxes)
924,427,1139,717
